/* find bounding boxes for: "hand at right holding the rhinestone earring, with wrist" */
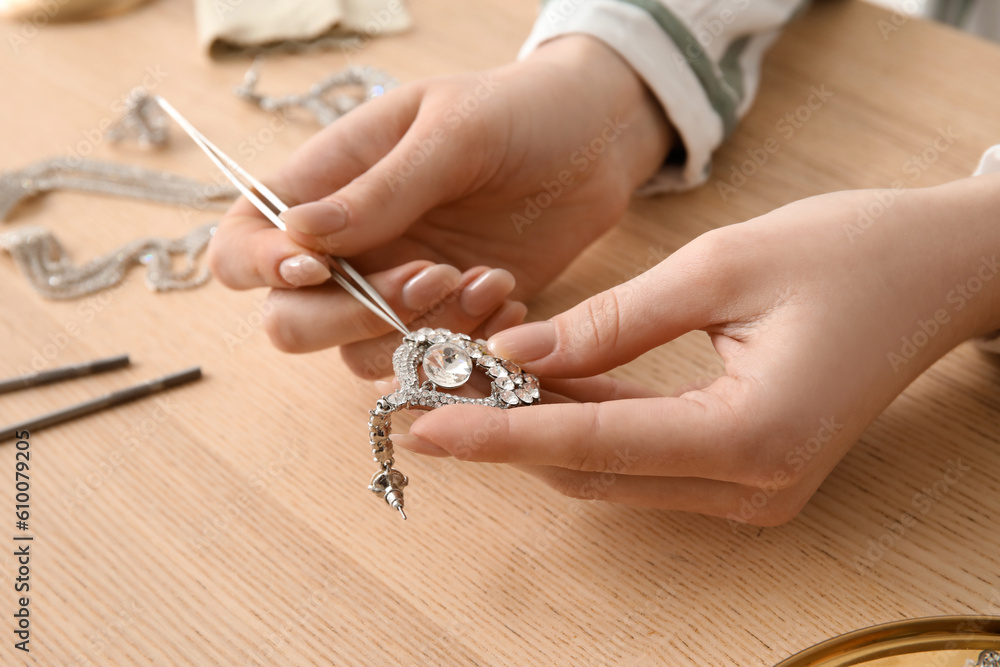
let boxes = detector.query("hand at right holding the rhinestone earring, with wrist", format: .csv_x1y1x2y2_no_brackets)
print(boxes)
388,176,1000,526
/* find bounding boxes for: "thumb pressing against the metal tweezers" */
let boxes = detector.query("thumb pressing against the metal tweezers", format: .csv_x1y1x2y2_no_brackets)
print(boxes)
281,123,463,256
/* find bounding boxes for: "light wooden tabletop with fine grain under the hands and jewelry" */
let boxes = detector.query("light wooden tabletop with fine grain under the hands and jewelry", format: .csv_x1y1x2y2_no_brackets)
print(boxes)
0,0,1000,665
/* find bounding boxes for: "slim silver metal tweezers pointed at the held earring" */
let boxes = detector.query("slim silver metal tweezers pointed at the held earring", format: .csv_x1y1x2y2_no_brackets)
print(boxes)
154,95,410,335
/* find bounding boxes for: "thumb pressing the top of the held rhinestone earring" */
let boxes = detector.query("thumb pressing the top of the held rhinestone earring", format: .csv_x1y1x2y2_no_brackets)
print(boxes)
488,255,714,377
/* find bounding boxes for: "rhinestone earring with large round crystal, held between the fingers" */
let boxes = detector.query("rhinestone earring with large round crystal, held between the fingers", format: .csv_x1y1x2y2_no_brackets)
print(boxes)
368,327,540,519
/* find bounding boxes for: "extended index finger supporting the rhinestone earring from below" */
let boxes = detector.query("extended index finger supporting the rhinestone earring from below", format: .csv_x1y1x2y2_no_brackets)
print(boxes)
400,378,756,483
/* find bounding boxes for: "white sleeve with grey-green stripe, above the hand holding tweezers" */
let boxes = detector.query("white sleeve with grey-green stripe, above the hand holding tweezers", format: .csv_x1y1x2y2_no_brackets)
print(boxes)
518,0,808,194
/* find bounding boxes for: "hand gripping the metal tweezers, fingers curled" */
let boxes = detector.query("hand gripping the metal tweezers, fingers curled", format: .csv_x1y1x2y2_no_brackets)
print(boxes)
210,35,673,375
